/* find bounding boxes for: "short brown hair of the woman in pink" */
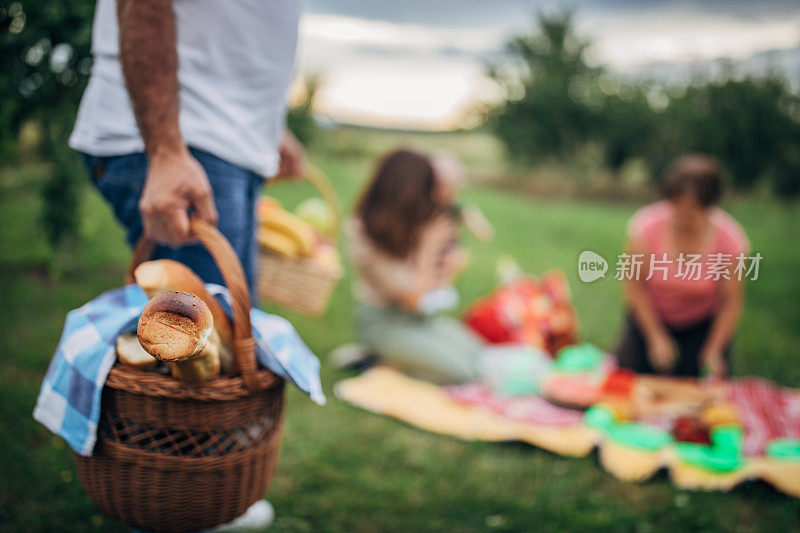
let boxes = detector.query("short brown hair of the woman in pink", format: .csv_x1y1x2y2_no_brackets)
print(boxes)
662,154,725,207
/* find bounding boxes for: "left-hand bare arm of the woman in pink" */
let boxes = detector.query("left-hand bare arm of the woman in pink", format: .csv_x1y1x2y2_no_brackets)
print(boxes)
623,241,678,372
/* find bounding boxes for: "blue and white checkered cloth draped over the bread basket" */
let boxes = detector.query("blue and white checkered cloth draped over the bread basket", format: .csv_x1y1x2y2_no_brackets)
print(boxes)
33,284,325,455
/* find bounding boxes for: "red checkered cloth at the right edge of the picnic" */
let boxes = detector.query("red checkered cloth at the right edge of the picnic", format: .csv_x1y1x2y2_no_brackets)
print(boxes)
728,378,800,456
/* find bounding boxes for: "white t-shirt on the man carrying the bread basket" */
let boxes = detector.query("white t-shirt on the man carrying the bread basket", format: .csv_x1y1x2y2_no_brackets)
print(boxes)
69,0,300,177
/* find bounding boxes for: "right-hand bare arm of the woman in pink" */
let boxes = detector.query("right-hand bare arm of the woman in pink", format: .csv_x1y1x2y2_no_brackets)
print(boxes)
700,278,744,377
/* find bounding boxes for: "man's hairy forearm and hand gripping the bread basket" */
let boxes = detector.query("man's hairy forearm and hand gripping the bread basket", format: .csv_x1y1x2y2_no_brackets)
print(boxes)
117,0,217,245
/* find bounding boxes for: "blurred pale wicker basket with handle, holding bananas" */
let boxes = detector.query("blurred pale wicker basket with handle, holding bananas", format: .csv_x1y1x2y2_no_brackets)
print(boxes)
258,165,342,316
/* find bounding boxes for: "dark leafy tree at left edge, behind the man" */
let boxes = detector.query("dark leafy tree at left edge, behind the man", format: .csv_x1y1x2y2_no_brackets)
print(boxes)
0,0,94,246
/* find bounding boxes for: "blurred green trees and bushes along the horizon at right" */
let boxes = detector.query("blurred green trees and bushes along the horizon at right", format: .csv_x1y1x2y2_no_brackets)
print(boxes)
486,12,800,197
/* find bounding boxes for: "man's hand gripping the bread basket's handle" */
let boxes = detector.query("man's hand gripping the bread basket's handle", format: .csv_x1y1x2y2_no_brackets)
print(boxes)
139,148,217,246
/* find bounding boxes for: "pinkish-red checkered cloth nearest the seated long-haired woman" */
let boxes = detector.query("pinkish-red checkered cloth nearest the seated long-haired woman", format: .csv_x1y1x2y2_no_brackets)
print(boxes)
446,383,583,426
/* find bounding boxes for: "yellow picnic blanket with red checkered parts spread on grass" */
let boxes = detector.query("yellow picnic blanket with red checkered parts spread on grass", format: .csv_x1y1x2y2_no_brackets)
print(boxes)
334,366,800,497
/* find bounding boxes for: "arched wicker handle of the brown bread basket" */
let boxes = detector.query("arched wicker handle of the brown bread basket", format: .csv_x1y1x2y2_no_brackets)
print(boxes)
125,218,260,391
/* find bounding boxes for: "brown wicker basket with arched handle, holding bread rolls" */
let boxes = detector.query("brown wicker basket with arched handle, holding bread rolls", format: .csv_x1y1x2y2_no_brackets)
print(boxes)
76,220,284,531
